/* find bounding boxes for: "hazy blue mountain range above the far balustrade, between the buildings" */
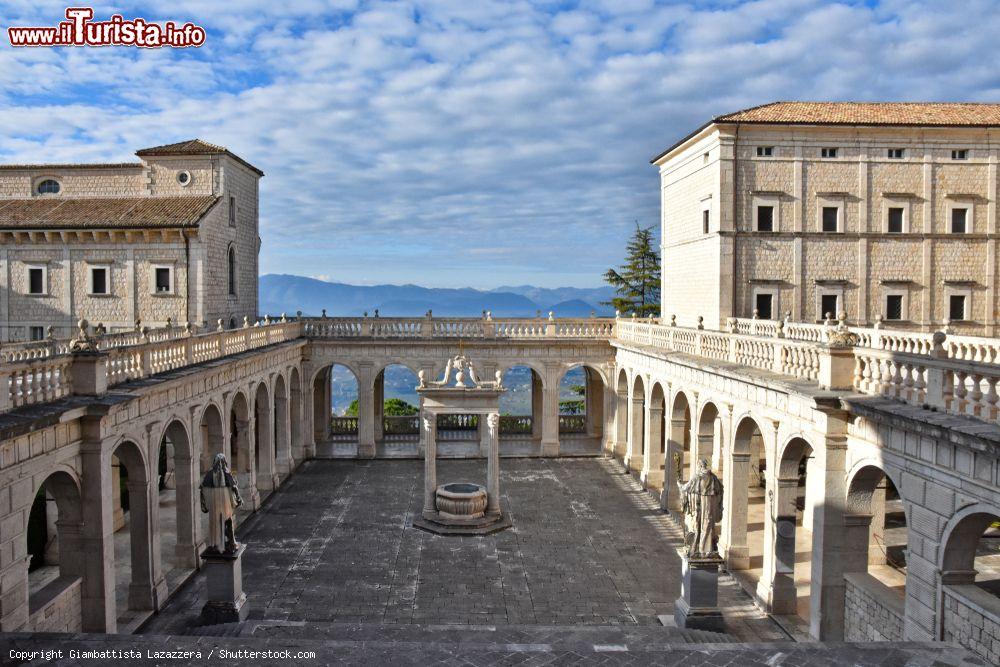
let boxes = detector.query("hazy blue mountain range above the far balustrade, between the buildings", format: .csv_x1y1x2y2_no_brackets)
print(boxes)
259,274,614,317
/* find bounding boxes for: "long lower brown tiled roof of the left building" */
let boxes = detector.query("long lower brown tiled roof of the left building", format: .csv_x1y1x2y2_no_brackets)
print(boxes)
0,195,221,230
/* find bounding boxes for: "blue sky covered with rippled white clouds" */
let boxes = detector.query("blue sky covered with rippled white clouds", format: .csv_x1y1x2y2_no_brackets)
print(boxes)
0,0,1000,287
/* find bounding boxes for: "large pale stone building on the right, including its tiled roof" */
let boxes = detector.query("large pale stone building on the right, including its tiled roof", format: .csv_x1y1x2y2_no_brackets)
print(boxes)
652,102,1000,336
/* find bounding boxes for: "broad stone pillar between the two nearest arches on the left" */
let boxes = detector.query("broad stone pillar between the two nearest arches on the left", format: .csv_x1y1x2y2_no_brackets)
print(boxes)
80,428,118,633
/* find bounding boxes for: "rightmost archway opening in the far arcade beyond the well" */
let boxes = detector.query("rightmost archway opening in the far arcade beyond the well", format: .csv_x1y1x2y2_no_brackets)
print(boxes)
559,365,604,453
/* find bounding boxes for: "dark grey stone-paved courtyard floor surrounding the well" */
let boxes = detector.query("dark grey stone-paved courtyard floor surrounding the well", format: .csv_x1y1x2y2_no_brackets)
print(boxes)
144,459,787,641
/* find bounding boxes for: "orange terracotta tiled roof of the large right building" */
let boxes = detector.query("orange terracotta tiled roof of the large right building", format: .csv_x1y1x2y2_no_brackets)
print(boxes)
714,102,1000,127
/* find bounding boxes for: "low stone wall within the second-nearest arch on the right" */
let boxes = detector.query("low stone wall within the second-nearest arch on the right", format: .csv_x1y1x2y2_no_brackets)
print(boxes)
844,572,904,642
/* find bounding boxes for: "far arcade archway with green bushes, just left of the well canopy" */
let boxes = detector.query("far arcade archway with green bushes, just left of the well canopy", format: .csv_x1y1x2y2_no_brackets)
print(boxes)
373,364,420,451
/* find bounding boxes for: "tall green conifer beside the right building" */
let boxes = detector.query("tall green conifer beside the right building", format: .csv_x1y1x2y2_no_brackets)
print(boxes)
604,222,660,317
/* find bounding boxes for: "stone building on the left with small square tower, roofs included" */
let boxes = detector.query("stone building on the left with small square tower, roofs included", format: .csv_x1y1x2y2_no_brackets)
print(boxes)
0,140,263,341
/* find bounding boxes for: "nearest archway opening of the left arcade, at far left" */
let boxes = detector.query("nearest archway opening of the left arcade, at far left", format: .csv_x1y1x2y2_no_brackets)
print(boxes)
25,471,84,632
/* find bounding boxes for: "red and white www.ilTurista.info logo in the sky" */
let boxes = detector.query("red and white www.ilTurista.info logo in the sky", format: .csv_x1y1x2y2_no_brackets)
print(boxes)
7,7,205,49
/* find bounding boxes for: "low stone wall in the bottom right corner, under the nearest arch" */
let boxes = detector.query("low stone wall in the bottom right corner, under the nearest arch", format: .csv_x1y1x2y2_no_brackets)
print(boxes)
943,585,1000,665
